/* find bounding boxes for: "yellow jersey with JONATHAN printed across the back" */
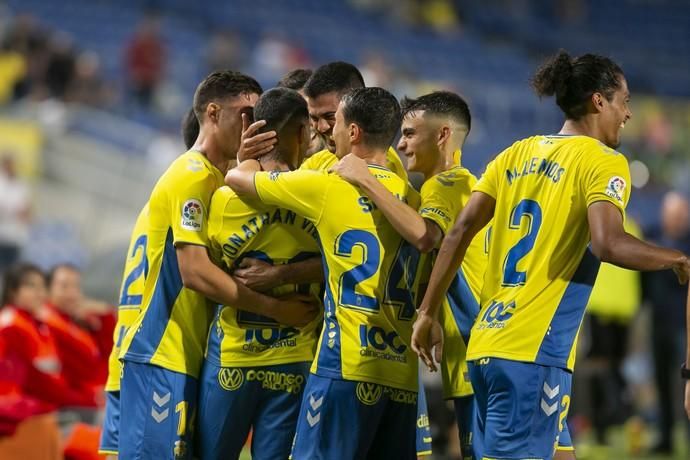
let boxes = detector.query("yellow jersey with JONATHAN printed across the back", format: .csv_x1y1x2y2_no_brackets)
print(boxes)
206,187,323,367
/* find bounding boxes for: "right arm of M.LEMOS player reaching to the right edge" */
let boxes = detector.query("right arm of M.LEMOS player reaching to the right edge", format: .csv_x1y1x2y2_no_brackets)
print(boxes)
587,201,690,283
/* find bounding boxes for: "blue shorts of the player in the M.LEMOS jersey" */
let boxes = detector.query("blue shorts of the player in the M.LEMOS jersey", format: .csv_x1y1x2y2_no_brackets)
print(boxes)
468,358,572,460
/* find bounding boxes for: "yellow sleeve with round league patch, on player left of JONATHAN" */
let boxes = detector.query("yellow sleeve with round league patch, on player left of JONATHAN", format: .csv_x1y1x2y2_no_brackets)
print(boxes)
166,168,217,246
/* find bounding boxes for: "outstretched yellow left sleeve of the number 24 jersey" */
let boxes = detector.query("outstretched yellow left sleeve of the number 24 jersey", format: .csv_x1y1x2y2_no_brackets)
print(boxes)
254,169,333,223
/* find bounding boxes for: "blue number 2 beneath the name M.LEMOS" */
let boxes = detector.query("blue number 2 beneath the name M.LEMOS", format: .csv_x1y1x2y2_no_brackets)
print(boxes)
503,200,541,286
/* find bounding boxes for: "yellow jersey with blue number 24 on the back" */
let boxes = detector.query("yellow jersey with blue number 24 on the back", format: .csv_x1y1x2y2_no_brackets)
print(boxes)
254,165,419,391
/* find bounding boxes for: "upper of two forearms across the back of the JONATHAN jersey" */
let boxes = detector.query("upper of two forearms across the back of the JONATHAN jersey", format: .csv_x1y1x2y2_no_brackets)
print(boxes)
232,257,324,292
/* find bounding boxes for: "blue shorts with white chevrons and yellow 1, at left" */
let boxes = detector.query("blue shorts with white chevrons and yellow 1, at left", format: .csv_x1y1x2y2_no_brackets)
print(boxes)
119,361,198,460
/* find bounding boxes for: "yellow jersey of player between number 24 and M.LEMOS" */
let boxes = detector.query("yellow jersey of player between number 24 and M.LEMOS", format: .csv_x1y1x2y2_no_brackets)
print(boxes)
419,165,489,398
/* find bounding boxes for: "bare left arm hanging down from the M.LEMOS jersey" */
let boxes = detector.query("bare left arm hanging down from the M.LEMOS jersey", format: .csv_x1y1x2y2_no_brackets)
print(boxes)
412,192,496,371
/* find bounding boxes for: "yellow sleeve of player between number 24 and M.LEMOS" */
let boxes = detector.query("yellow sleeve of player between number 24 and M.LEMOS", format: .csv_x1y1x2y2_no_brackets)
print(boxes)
419,174,472,235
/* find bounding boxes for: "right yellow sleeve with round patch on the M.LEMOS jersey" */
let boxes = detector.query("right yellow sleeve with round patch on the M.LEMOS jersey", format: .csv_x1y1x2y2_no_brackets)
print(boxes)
582,151,630,216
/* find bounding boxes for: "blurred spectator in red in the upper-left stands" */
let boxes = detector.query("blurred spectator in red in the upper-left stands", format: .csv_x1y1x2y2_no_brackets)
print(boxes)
126,15,166,108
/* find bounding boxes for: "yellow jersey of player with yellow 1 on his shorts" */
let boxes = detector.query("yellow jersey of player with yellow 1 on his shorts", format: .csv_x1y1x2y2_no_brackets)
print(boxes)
120,150,224,378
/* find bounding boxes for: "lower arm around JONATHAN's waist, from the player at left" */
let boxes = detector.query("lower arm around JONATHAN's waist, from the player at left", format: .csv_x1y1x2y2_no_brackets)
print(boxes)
176,244,318,327
